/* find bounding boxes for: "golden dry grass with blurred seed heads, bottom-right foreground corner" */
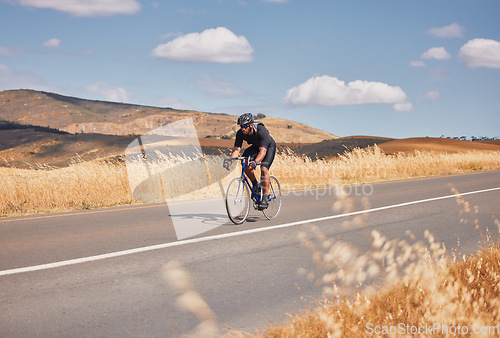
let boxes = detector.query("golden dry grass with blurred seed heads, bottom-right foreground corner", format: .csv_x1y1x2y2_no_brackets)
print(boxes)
229,191,500,338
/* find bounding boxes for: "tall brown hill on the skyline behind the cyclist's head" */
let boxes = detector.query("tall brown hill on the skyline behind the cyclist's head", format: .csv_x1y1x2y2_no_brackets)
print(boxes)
0,90,337,143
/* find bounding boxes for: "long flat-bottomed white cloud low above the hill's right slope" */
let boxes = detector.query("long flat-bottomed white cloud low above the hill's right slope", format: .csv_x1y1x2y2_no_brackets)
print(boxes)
284,75,411,108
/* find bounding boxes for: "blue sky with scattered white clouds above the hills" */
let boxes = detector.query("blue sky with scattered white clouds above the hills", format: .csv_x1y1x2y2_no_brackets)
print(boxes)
0,0,500,138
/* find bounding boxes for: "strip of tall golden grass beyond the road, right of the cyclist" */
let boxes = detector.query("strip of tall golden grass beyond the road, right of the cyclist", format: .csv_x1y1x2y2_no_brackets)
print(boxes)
271,146,500,189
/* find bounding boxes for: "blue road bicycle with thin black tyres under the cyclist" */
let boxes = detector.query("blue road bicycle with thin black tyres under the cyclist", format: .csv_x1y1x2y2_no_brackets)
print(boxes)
226,157,281,224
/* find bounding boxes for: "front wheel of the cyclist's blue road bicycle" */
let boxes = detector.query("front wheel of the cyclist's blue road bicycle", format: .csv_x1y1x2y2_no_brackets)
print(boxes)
226,177,250,224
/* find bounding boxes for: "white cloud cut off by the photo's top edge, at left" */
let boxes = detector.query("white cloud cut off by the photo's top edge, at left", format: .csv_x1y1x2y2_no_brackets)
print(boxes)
17,0,141,16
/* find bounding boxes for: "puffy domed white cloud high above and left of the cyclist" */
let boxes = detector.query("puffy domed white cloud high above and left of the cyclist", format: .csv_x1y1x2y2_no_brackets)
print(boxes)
151,27,254,63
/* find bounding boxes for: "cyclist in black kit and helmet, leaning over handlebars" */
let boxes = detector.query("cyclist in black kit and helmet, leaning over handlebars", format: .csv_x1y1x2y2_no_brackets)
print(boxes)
224,113,276,210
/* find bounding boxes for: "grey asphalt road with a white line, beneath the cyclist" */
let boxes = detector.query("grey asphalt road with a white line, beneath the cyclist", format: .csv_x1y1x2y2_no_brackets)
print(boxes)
0,171,500,337
